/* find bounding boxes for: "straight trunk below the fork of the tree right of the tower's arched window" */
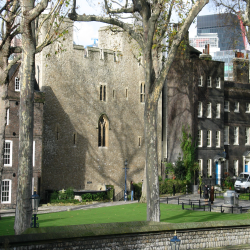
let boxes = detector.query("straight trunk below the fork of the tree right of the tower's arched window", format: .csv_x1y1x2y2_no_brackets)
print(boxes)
144,98,160,222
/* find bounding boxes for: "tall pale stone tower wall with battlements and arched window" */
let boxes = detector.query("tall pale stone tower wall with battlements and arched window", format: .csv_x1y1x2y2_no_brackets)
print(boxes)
36,19,161,197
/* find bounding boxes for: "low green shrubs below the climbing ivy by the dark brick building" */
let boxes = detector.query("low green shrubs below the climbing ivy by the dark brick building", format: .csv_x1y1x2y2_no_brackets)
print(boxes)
159,179,190,194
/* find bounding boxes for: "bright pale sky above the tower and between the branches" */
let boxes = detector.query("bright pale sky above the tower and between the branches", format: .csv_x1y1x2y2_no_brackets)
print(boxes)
74,0,216,46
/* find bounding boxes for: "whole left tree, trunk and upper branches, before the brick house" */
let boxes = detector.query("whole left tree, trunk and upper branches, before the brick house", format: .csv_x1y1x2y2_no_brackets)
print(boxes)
1,0,71,234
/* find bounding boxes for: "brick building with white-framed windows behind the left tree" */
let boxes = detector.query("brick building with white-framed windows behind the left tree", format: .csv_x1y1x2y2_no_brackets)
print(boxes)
1,64,44,208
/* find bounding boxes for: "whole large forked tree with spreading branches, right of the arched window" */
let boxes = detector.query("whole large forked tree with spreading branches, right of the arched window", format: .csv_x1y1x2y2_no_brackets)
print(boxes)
69,0,209,221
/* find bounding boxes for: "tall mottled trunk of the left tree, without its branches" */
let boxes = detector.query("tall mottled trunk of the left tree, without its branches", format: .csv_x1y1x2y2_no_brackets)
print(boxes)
14,1,35,234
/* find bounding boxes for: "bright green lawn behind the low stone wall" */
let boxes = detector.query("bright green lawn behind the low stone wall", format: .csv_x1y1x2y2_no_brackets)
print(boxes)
0,203,250,235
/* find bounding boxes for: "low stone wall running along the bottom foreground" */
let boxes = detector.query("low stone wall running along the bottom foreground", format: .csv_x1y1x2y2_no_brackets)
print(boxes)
0,224,250,250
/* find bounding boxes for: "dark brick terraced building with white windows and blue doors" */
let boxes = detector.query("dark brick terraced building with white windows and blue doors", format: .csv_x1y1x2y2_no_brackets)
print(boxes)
163,45,250,185
